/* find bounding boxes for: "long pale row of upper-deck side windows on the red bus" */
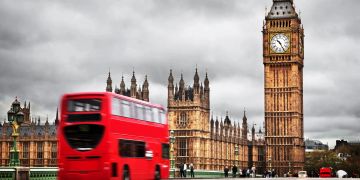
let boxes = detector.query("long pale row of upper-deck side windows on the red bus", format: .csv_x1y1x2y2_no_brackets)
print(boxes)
112,98,166,124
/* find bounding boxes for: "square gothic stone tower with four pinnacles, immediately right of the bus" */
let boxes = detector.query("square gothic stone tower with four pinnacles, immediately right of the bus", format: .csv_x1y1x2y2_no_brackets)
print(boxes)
168,69,211,169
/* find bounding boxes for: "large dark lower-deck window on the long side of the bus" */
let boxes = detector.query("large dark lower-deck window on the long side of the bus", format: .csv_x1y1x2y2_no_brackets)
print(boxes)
119,139,145,157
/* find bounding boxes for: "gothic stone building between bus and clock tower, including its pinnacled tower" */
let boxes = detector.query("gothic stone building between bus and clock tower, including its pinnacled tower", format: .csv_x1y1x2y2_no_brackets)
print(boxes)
168,69,264,171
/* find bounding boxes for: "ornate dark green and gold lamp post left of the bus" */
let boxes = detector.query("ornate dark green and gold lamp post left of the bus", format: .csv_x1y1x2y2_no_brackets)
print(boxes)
8,98,24,166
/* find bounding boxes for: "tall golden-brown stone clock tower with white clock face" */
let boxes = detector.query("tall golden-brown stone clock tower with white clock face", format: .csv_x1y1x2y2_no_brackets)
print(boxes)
263,0,305,175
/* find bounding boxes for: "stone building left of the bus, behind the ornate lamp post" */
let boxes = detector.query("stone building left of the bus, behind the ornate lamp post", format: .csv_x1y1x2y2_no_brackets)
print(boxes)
0,99,59,167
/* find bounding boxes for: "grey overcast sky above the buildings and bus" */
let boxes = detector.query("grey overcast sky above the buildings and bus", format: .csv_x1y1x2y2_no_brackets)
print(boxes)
0,0,360,146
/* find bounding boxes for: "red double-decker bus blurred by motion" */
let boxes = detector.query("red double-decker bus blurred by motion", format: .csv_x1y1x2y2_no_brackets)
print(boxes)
58,92,169,180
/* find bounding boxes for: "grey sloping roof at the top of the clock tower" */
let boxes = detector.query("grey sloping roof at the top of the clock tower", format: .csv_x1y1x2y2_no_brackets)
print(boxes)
266,0,298,19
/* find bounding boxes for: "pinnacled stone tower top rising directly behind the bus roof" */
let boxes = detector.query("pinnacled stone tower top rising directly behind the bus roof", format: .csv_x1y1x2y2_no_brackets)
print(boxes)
105,71,149,102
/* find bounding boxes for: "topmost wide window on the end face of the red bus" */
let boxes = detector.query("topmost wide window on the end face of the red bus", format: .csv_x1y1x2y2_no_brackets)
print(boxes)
68,99,101,112
